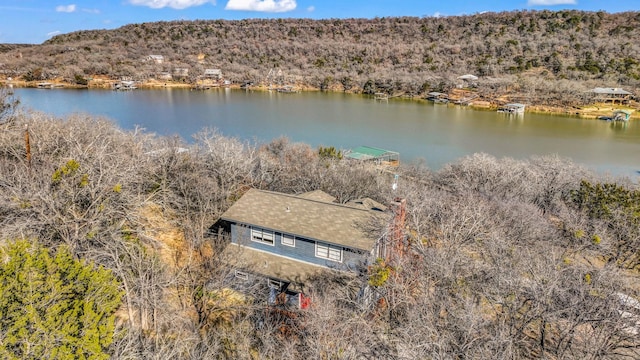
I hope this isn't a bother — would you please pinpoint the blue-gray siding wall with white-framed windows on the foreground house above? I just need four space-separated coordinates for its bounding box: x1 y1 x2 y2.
231 224 369 270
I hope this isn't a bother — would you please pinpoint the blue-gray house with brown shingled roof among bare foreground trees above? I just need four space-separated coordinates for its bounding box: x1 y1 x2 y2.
221 189 400 305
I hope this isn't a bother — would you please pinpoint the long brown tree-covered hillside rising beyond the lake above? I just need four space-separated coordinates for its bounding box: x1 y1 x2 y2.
0 11 640 102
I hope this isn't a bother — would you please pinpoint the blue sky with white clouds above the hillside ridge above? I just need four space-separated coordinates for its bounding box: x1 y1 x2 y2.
0 0 640 44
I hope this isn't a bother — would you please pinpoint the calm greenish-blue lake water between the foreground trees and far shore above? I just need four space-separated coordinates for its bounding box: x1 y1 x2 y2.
15 88 640 179
